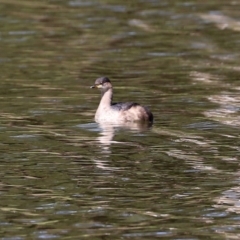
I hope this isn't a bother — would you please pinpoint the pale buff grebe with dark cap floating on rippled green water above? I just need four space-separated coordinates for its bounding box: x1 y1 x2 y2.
91 77 153 123
